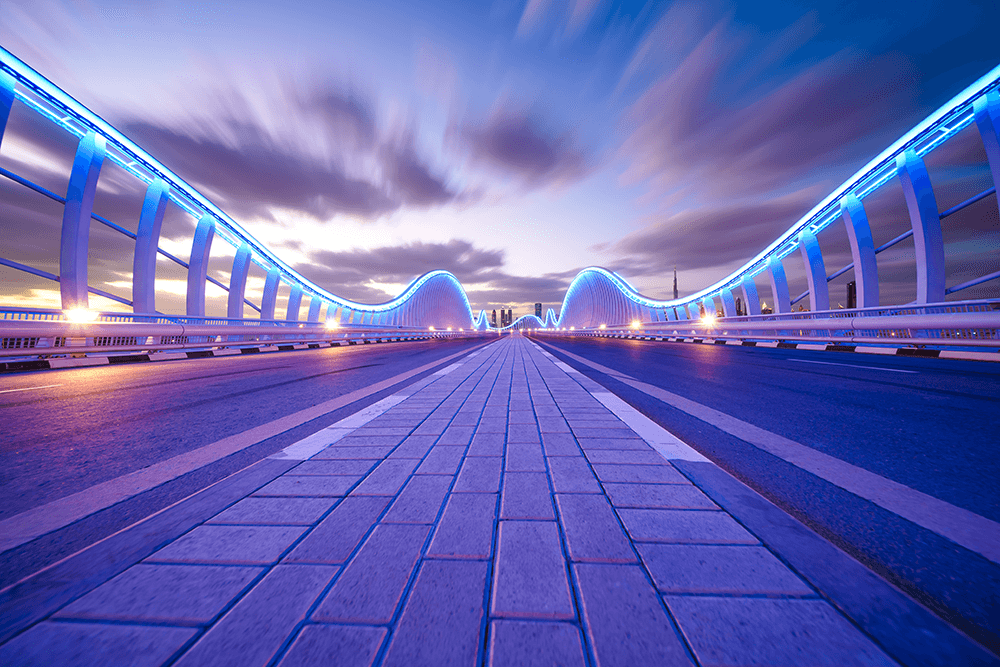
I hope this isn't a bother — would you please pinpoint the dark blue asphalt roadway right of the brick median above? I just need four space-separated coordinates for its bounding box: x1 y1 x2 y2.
536 336 1000 651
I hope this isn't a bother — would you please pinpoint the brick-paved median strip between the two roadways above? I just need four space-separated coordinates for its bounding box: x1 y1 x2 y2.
0 337 897 667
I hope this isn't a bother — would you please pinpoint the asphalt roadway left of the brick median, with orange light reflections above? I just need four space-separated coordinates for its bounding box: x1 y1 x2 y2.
0 339 486 589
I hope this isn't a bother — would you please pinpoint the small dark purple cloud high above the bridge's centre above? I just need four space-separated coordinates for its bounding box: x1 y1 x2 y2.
458 108 590 189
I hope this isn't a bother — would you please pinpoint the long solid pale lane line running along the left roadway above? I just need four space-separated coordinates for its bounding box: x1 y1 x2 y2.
0 342 488 553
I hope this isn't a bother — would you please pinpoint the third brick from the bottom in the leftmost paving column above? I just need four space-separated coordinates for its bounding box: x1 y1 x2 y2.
148 525 306 565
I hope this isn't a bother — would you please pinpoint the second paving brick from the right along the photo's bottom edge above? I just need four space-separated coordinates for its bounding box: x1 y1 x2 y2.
573 563 693 667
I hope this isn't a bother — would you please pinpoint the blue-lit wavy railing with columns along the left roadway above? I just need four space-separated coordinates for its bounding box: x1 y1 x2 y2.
0 48 485 329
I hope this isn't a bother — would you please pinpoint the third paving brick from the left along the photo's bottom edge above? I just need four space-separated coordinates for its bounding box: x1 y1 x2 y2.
278 625 386 667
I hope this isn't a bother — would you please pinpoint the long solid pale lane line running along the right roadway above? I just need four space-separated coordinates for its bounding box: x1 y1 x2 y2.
549 343 1000 563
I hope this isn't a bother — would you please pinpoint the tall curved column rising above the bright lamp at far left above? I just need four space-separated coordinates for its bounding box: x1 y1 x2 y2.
59 132 107 309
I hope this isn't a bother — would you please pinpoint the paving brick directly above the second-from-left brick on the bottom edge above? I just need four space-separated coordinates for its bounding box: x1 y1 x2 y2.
283 496 391 563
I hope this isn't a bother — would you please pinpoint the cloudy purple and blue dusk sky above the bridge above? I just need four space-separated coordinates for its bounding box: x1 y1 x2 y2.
0 0 1000 313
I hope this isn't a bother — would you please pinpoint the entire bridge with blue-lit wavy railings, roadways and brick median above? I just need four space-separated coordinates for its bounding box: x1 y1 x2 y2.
0 44 1000 665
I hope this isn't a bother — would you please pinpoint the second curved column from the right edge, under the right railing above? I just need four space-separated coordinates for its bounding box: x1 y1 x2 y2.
896 149 944 303
